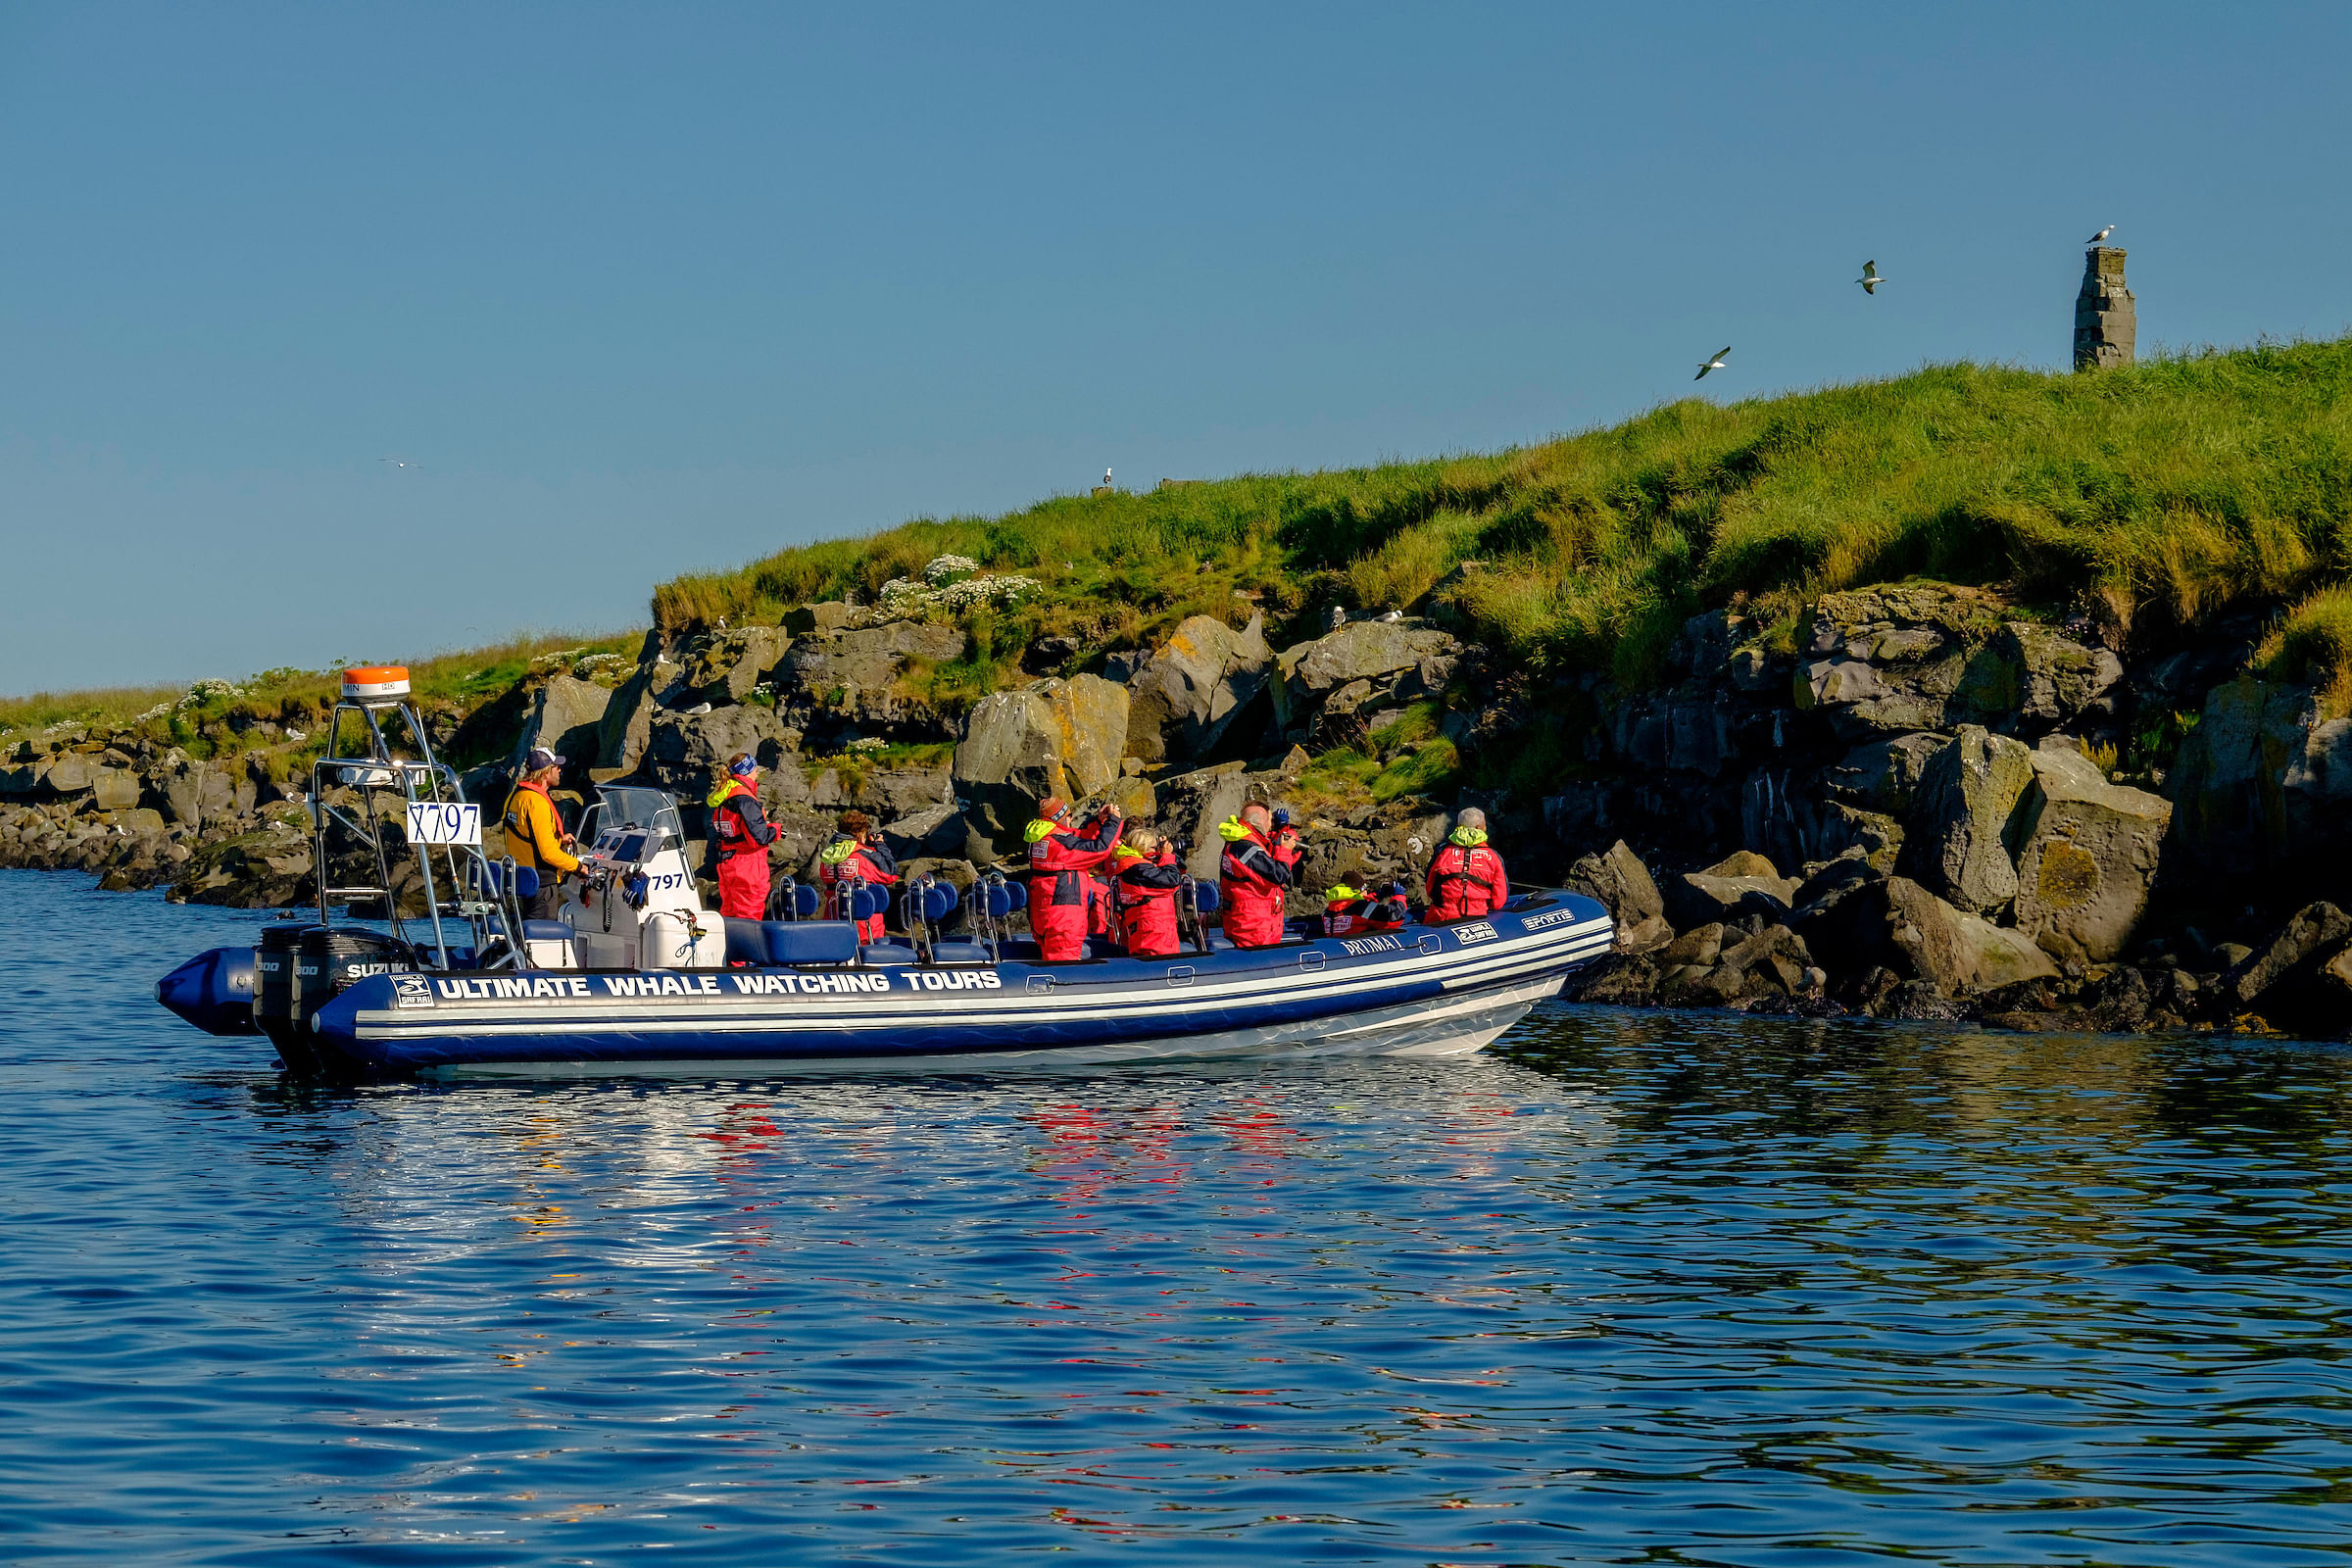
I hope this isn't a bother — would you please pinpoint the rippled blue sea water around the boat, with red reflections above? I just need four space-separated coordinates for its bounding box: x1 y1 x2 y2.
0 872 2352 1568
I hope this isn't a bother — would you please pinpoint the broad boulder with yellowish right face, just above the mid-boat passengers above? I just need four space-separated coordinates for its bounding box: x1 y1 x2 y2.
955 674 1127 856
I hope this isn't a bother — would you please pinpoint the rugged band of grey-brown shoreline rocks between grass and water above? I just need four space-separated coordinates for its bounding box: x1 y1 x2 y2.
0 562 2352 1034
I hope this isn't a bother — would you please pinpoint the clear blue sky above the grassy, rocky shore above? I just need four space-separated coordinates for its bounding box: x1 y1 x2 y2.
0 0 2352 691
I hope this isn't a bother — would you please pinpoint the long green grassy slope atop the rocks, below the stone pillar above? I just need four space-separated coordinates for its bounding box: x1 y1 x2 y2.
654 338 2352 679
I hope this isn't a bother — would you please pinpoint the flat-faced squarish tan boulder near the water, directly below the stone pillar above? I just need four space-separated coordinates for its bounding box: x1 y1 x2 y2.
2016 738 2174 964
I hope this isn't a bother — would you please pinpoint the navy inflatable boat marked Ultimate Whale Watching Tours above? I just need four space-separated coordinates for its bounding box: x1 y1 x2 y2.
155 670 1613 1077
